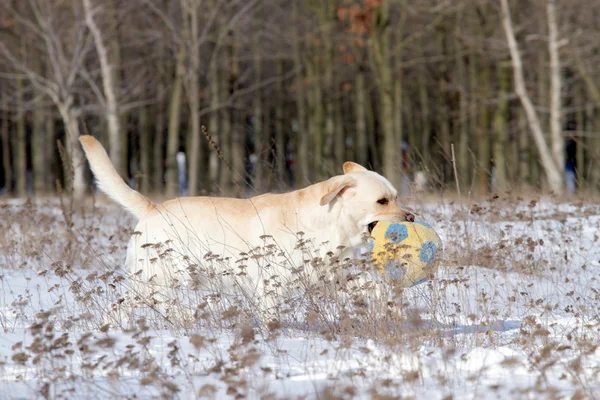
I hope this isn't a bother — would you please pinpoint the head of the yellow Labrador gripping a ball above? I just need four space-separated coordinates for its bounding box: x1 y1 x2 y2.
320 162 415 245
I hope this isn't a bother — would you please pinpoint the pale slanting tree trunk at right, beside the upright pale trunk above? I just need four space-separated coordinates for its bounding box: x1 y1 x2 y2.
500 0 564 194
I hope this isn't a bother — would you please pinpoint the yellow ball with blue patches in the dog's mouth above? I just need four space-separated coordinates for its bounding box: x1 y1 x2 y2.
370 221 442 287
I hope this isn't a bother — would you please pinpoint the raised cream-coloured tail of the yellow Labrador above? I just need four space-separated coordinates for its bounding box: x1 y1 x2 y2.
79 135 154 219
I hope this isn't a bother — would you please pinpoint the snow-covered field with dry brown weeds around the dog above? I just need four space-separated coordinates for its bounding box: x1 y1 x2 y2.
0 195 600 399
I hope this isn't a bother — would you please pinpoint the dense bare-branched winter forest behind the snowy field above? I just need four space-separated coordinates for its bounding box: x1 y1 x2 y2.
0 0 600 198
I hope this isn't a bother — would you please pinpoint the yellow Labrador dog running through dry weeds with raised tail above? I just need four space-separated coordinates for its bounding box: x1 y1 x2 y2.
80 136 414 314
